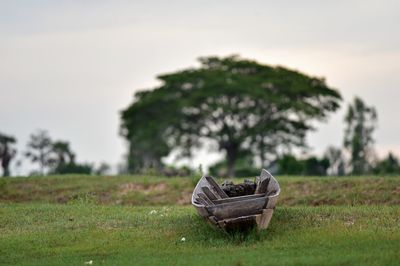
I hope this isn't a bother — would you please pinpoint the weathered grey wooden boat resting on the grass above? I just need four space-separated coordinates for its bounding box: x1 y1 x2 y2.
192 169 280 231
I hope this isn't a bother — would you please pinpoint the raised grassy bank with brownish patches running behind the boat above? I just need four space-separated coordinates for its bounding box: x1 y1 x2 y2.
0 176 400 206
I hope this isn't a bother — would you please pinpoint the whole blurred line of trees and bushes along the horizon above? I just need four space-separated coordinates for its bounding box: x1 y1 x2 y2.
0 55 400 177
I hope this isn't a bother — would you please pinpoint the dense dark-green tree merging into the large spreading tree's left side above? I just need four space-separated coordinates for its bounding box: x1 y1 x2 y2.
121 90 180 173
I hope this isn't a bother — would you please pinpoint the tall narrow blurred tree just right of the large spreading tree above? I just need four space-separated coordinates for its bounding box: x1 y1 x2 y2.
344 97 377 175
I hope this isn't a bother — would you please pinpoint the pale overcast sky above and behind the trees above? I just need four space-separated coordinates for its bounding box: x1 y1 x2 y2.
0 0 400 175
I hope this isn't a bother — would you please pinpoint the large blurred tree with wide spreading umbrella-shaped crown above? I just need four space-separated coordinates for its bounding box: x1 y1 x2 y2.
121 56 341 176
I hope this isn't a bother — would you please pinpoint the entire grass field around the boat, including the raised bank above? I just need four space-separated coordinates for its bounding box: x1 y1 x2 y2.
0 176 400 265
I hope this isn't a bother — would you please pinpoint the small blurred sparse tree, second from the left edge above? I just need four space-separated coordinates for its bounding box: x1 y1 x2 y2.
25 130 54 175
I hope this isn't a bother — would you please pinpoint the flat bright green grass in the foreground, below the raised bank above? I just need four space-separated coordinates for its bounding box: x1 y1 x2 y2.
0 202 400 265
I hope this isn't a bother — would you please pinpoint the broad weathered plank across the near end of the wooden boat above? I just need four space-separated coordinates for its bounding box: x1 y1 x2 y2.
206 197 268 220
